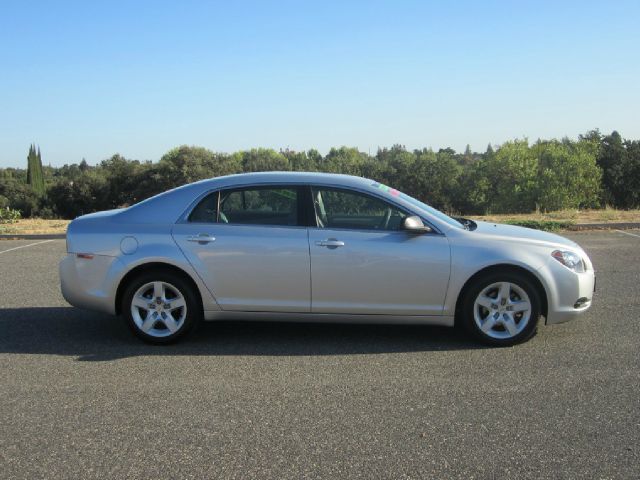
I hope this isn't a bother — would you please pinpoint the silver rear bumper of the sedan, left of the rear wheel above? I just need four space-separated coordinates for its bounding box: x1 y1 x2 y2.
59 253 122 315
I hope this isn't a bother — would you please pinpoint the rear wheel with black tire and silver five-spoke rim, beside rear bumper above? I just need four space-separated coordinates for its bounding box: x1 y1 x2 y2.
121 270 202 345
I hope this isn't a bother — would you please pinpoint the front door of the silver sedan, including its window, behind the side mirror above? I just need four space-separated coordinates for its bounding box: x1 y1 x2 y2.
309 186 450 315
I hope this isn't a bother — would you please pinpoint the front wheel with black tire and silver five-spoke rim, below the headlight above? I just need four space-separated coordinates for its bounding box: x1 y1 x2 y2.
461 272 541 347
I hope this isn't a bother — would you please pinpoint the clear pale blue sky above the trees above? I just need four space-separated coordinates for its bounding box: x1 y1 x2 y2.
0 0 640 167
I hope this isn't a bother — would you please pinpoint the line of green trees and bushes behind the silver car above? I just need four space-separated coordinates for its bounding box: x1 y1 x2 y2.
0 130 640 218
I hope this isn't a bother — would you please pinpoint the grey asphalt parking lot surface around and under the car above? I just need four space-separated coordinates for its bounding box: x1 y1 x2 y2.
0 230 640 479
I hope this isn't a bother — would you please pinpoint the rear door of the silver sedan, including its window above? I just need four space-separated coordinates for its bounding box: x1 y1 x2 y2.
173 185 311 312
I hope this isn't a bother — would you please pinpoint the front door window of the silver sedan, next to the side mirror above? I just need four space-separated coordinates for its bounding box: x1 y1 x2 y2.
313 187 407 230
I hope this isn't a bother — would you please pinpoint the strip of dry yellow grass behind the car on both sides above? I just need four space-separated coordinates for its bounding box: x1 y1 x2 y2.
0 208 640 235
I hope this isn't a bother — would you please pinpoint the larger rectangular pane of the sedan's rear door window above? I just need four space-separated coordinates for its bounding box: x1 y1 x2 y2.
218 187 298 225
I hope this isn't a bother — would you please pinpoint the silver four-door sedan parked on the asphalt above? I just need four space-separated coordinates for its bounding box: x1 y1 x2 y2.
60 172 595 346
